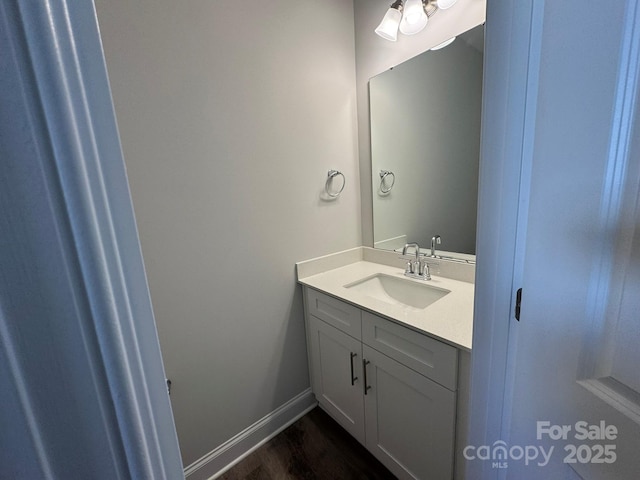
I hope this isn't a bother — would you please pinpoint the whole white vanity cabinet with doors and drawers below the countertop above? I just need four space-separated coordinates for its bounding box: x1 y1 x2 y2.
305 287 458 479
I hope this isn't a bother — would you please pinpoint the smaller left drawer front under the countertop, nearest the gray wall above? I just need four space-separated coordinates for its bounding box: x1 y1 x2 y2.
307 288 362 339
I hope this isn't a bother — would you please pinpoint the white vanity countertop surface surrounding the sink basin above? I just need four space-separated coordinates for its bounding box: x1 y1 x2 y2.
298 260 474 351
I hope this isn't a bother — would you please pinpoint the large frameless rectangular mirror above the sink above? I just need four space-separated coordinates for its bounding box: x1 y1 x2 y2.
369 25 484 259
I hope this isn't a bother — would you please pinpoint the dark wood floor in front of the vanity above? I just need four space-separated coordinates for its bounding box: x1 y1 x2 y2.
219 407 396 480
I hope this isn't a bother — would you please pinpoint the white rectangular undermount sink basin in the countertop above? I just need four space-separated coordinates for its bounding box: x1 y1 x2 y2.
345 273 451 309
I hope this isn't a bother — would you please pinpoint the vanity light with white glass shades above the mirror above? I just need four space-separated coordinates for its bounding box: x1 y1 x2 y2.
375 0 457 42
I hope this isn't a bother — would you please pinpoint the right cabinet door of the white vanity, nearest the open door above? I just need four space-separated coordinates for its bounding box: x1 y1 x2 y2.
363 345 456 480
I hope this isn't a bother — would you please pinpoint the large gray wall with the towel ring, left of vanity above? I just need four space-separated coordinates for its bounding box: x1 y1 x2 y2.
96 0 362 465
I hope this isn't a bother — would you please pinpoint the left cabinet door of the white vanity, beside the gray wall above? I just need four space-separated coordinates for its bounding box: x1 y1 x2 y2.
309 315 364 445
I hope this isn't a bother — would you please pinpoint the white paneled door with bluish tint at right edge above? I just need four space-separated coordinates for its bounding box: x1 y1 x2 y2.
498 0 640 480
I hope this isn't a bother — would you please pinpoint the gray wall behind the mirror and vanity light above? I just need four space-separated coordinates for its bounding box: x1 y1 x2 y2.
353 0 486 246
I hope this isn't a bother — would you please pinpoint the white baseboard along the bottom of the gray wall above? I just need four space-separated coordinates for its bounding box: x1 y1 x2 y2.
184 388 318 480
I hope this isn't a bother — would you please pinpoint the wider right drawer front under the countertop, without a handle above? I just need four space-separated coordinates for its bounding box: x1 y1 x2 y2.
362 312 458 390
